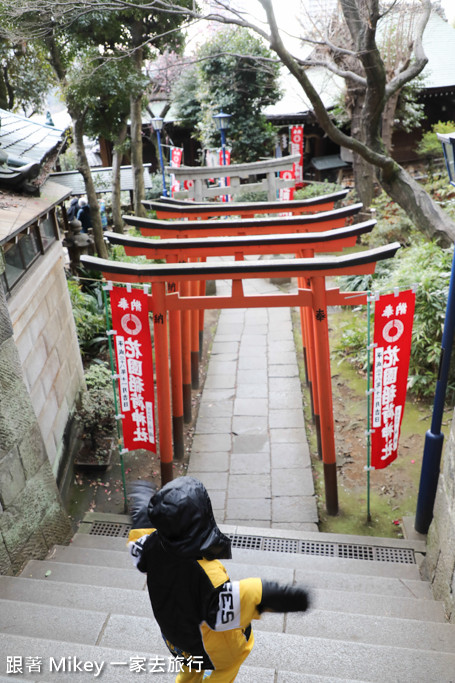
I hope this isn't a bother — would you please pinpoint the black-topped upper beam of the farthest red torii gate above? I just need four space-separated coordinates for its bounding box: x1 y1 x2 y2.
142 189 349 220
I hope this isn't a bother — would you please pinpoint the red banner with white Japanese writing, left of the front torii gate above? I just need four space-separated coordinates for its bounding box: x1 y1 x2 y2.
110 287 156 453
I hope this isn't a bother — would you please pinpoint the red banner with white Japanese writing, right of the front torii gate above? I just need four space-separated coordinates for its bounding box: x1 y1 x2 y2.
371 290 415 470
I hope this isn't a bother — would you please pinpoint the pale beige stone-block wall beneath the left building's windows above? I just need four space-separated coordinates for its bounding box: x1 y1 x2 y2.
8 242 84 476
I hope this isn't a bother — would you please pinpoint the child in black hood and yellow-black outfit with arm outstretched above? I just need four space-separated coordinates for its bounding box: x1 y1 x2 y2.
128 477 308 683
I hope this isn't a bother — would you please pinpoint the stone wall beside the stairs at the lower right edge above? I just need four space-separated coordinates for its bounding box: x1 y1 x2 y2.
426 413 455 623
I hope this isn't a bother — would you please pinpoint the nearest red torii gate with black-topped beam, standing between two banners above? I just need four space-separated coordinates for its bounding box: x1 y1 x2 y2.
81 242 400 515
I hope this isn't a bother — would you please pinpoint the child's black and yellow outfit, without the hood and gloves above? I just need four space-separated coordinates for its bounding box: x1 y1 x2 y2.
128 530 262 669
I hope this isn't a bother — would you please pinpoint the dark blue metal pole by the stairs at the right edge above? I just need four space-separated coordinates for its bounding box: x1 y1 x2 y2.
414 246 455 534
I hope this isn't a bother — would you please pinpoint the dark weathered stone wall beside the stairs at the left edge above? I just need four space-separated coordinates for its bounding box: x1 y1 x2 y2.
0 270 71 574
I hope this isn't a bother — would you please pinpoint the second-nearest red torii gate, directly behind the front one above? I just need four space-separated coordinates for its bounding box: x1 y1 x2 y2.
105 220 376 458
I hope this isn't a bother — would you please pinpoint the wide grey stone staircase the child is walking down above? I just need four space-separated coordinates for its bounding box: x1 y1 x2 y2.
0 513 455 683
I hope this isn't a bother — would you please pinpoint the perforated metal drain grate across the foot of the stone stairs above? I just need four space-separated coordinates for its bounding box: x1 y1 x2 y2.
90 521 416 564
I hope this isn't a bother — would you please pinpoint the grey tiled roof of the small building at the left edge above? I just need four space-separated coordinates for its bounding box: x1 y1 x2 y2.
0 109 64 164
